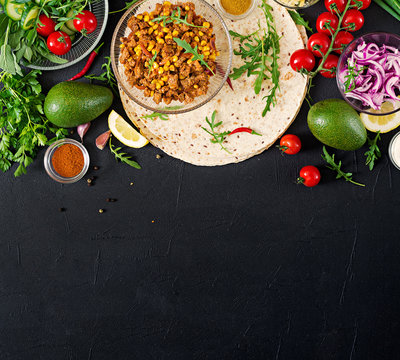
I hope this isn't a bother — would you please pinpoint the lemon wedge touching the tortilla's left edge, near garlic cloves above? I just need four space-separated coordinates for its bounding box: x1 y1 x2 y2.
108 110 149 149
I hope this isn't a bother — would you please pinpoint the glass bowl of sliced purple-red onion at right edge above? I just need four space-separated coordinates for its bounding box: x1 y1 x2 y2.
336 32 400 115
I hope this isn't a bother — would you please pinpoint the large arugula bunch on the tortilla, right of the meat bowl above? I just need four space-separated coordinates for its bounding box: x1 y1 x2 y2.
230 0 280 116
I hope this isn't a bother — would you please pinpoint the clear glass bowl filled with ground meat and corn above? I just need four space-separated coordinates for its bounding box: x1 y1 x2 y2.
111 0 232 114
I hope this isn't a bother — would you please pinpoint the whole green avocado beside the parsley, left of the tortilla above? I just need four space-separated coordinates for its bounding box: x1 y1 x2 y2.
44 81 114 128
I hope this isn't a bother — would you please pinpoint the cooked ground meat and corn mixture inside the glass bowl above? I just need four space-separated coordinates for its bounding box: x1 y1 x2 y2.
120 1 219 105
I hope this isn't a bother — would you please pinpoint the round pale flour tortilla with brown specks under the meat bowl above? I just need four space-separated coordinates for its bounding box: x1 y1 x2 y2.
120 0 307 166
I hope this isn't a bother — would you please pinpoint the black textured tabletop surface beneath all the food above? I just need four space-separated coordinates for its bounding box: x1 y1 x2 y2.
0 0 400 360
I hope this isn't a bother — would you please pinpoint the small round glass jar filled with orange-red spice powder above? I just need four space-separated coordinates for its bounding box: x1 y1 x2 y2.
44 139 90 184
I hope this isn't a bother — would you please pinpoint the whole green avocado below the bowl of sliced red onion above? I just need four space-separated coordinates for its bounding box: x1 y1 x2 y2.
307 99 367 151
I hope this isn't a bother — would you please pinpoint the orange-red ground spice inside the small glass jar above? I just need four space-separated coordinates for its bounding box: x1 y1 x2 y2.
51 144 85 178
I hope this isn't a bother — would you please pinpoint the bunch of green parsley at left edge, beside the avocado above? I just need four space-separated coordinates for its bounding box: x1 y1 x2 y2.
0 70 68 176
